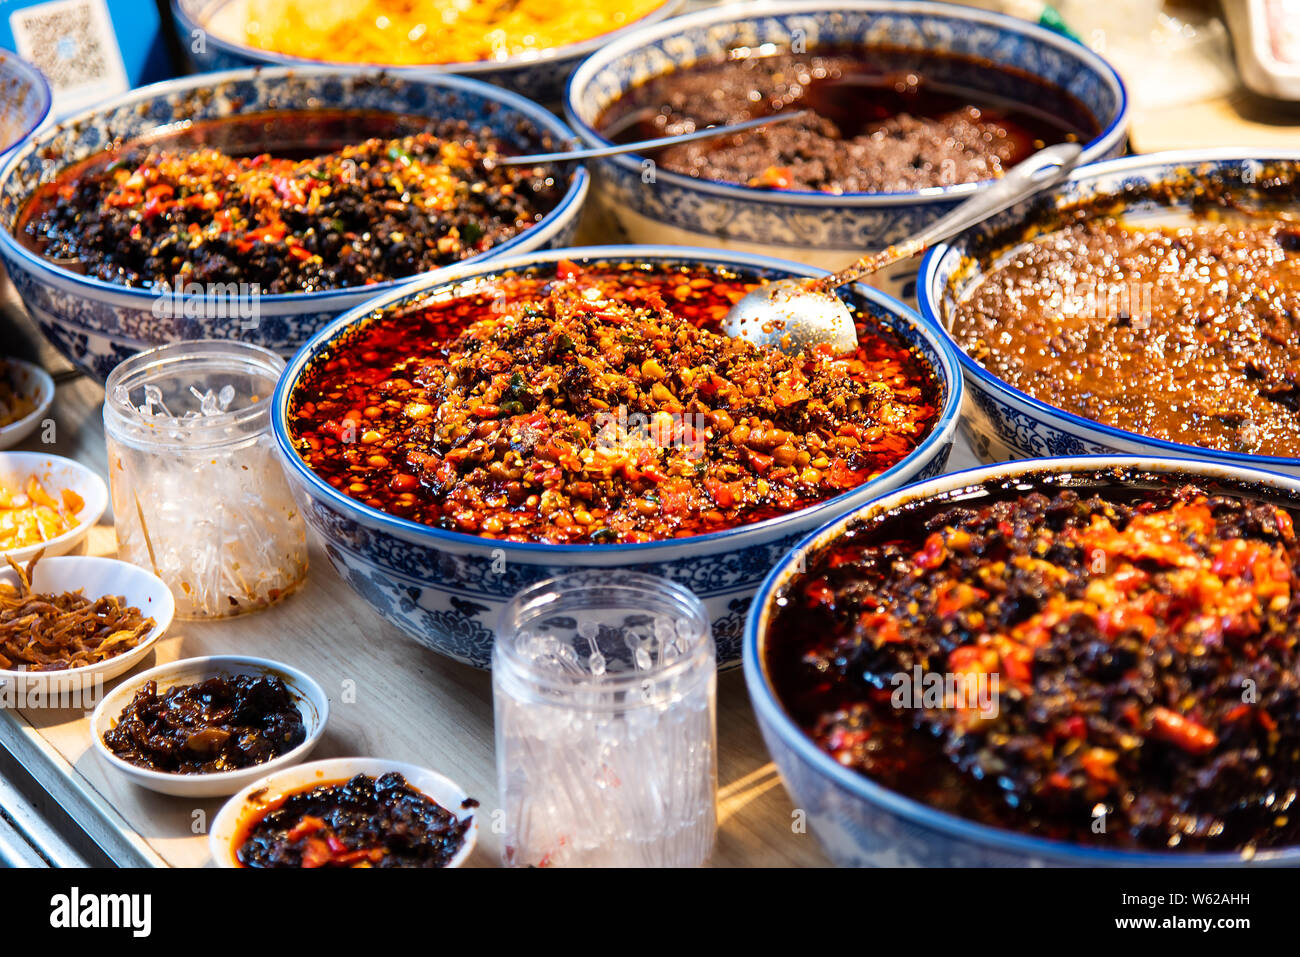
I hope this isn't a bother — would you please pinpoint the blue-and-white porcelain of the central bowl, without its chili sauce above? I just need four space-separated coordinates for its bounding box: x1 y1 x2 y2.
272 246 962 668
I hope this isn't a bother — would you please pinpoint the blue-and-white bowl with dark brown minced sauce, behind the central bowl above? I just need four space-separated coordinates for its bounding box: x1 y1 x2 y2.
564 0 1127 298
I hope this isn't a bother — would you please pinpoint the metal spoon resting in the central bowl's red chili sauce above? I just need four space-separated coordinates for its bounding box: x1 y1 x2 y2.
722 143 1083 355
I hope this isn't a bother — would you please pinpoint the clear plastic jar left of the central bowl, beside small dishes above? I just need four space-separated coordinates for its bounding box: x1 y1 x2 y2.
104 339 307 618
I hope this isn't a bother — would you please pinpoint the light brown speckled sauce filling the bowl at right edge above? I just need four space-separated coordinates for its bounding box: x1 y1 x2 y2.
952 215 1300 456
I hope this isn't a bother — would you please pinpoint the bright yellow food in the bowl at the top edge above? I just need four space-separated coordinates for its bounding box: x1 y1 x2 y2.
230 0 666 66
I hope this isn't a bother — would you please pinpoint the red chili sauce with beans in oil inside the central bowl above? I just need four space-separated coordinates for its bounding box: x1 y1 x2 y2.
289 263 940 544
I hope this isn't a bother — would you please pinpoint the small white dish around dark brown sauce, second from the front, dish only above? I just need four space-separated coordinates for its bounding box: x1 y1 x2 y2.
89 650 329 797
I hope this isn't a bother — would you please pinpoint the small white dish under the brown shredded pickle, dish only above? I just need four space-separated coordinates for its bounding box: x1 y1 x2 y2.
0 555 176 706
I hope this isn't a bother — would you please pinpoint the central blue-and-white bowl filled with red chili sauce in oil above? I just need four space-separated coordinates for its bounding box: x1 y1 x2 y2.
272 246 961 667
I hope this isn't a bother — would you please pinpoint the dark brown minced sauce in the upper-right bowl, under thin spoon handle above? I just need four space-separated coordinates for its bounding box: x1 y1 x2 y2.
597 47 1100 192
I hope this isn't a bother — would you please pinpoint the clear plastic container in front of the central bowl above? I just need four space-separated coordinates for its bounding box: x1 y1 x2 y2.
493 571 718 867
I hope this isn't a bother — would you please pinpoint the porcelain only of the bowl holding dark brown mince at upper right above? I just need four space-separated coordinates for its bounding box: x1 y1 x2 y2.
564 0 1128 295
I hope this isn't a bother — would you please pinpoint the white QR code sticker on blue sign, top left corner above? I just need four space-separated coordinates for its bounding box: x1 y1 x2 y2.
9 0 129 113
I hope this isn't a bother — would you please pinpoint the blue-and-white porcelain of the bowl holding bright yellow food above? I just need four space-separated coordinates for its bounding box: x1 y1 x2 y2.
172 0 685 103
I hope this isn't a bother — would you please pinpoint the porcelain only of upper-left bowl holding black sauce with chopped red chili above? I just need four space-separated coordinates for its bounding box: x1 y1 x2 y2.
0 68 589 380
